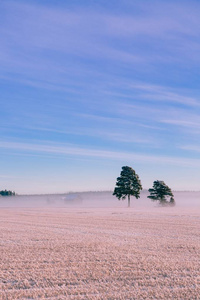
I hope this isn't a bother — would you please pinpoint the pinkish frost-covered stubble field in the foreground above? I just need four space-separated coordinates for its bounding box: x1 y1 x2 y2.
0 193 200 300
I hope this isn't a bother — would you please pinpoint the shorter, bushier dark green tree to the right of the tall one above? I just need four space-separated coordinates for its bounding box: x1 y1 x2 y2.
148 180 175 205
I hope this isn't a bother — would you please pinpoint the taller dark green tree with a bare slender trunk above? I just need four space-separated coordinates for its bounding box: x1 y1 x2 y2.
113 166 142 207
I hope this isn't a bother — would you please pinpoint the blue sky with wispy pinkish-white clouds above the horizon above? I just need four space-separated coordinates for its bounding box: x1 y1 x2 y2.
0 0 200 194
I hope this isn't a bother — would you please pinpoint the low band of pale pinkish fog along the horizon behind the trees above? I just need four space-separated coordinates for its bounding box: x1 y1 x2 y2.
0 190 200 209
